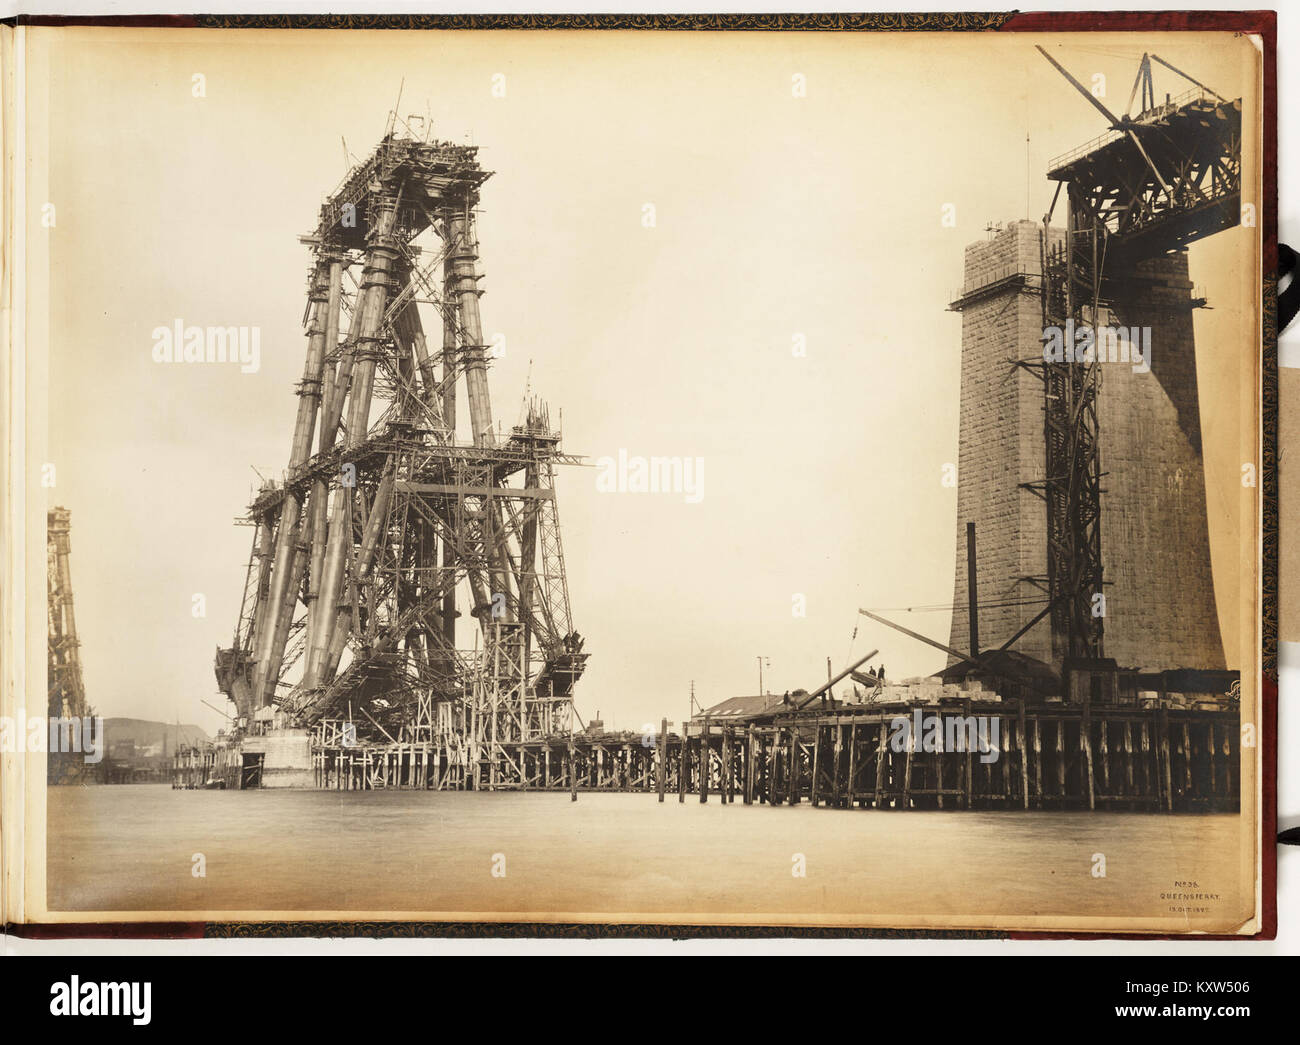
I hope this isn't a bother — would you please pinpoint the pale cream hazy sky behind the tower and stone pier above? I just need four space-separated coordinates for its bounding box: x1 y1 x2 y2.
33 29 1257 730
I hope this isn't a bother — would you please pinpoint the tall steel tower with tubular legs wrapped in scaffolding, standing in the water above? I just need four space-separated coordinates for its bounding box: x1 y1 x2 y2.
216 117 588 786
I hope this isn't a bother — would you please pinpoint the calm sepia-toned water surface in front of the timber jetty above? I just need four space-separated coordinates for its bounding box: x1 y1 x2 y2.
47 785 1240 922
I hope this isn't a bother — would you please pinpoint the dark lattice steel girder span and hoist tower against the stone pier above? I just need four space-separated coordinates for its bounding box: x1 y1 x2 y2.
1027 47 1242 659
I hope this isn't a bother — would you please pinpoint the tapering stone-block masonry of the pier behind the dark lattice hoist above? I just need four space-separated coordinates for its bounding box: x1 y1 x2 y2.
949 221 1223 671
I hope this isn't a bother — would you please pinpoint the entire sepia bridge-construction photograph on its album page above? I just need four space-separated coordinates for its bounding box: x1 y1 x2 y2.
3 8 1278 938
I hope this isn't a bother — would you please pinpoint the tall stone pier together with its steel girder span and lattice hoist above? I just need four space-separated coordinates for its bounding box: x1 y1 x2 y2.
952 55 1242 669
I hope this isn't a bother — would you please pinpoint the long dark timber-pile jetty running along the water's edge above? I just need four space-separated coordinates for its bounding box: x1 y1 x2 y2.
276 697 1242 812
